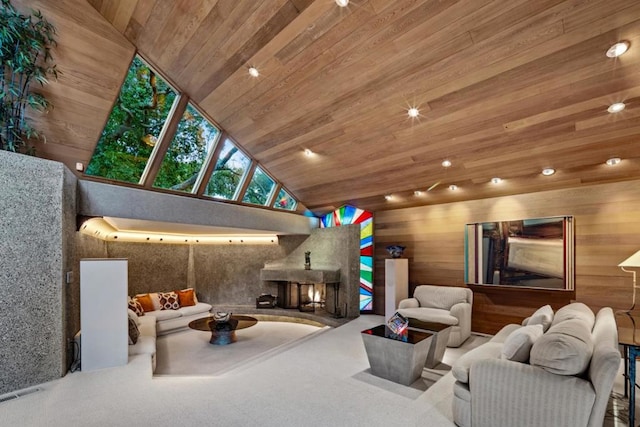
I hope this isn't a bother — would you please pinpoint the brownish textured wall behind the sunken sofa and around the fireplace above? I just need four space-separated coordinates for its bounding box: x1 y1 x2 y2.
78 231 360 317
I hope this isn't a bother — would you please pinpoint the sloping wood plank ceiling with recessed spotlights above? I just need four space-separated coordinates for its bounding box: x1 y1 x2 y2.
28 0 640 213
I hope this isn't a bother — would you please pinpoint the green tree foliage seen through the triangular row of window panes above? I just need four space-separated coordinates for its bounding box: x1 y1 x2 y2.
86 56 295 209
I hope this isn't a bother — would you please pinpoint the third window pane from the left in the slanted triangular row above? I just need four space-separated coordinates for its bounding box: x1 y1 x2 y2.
204 138 251 200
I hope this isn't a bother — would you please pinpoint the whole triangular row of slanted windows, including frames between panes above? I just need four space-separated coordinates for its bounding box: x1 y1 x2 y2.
83 55 298 211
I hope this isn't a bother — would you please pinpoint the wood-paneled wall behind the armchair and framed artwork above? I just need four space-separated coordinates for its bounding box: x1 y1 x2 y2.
374 181 640 333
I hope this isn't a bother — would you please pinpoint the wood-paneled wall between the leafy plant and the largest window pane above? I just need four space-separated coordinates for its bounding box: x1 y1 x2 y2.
12 0 135 170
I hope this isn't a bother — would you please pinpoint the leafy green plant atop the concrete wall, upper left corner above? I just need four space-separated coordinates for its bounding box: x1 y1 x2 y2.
0 0 58 153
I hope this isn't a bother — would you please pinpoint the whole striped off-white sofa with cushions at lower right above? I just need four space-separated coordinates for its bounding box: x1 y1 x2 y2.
452 303 621 427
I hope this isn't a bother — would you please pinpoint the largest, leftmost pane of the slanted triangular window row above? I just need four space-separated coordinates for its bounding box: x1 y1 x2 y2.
85 56 178 183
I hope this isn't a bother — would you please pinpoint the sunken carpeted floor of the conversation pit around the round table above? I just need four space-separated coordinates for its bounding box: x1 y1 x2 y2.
154 322 330 376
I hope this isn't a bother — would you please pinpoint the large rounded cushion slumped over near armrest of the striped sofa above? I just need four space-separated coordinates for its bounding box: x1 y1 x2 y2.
529 318 593 375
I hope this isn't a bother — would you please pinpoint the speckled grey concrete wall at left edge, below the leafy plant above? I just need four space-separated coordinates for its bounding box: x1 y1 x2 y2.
0 151 75 394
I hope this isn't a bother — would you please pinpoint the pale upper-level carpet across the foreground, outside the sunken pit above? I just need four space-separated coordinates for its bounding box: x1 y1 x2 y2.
0 315 626 427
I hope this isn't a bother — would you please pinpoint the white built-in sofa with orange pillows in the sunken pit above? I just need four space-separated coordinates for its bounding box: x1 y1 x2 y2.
128 294 211 371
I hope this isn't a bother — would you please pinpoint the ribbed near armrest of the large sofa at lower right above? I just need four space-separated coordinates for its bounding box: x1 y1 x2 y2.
469 359 595 427
